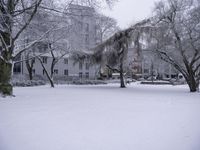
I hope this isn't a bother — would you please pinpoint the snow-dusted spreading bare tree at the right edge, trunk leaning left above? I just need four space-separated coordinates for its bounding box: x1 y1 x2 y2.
150 0 200 92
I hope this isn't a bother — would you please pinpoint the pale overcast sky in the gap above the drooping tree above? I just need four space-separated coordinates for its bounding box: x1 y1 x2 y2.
103 0 158 28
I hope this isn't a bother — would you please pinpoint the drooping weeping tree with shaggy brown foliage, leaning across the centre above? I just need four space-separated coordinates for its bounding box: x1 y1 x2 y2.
73 19 152 88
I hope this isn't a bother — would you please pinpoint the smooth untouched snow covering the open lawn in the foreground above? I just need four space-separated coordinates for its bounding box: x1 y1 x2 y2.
0 83 200 150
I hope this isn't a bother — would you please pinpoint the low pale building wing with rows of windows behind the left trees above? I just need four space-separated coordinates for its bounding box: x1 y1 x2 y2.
20 48 96 80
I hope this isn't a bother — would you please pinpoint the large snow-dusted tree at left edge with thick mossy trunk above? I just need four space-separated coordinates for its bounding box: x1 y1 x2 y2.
0 0 115 95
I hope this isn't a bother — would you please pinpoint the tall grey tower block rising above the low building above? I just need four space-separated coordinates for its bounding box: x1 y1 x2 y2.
68 4 97 50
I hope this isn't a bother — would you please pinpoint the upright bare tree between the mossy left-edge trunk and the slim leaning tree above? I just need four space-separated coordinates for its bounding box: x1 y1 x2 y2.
23 3 68 80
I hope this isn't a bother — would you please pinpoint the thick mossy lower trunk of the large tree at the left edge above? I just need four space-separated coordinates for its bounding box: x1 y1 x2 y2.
0 59 13 95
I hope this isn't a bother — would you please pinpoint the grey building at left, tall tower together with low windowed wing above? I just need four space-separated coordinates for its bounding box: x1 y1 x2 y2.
14 4 98 79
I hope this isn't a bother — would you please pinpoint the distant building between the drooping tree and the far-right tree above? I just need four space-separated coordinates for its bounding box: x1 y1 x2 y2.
127 48 178 79
